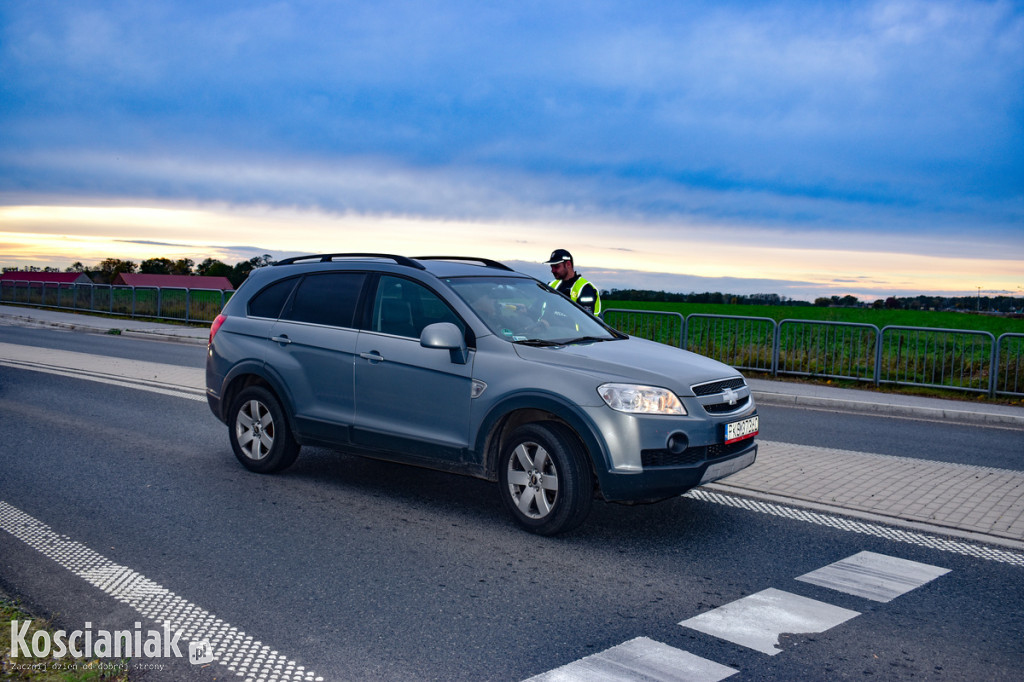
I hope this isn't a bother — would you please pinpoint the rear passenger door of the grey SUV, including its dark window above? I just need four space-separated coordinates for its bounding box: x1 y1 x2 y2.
266 272 367 442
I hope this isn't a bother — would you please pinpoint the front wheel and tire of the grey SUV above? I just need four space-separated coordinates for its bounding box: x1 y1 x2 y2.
498 422 594 536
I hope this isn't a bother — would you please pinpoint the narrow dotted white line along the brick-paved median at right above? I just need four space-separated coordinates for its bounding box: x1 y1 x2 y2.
683 488 1024 566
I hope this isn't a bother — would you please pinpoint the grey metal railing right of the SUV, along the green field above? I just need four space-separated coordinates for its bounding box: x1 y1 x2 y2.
601 308 1024 397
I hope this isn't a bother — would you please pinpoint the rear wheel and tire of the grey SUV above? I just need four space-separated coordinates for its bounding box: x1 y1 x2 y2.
227 386 299 473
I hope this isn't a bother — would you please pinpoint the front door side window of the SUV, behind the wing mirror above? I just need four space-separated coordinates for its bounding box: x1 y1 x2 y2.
371 274 466 339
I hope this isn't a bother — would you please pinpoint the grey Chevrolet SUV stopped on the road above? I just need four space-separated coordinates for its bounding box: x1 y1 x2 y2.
206 254 758 535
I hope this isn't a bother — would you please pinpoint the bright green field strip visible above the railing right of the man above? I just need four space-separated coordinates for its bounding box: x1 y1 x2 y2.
601 299 1024 337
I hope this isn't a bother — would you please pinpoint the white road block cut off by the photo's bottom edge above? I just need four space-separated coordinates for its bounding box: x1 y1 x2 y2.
527 637 738 682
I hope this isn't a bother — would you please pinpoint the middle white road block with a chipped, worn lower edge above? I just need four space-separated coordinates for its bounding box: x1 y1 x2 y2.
679 588 860 655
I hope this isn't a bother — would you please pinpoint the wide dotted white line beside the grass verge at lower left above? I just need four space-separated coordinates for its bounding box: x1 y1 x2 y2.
0 501 324 682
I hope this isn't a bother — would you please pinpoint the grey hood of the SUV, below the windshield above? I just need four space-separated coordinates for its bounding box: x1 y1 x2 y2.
515 337 739 395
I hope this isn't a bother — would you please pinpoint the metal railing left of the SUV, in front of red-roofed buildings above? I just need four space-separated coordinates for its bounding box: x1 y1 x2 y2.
0 281 233 322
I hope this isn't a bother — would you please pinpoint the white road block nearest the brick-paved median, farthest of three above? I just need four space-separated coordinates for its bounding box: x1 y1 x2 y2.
797 552 949 603
